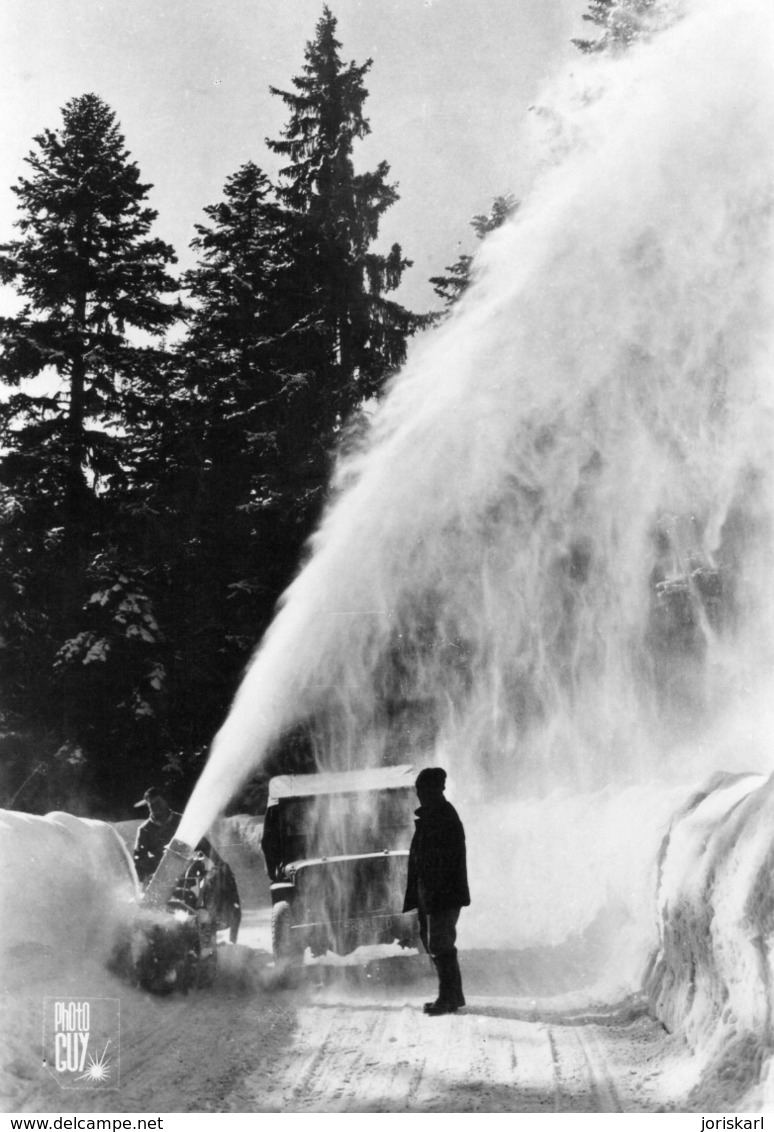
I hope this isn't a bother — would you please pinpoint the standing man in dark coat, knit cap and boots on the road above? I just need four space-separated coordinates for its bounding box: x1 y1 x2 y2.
403 766 471 1015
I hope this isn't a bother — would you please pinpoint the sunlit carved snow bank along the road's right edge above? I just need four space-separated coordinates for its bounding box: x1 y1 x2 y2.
646 774 774 1103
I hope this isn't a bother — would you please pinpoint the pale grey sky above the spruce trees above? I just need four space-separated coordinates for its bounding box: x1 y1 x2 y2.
0 0 587 309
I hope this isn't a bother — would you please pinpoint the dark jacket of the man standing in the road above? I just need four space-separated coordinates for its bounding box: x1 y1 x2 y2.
403 795 471 914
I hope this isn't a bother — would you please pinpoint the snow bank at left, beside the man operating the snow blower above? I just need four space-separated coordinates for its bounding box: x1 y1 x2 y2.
0 811 138 963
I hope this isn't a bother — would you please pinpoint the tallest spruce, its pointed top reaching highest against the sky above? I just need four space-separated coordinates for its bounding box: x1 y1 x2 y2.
267 7 421 487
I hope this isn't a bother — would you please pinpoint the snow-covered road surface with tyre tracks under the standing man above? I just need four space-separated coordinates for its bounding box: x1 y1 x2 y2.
0 937 706 1113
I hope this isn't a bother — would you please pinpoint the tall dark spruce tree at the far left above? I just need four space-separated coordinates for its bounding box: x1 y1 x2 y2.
0 94 179 787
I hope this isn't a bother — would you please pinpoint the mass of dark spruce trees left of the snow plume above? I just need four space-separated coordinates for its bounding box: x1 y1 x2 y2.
0 0 665 816
